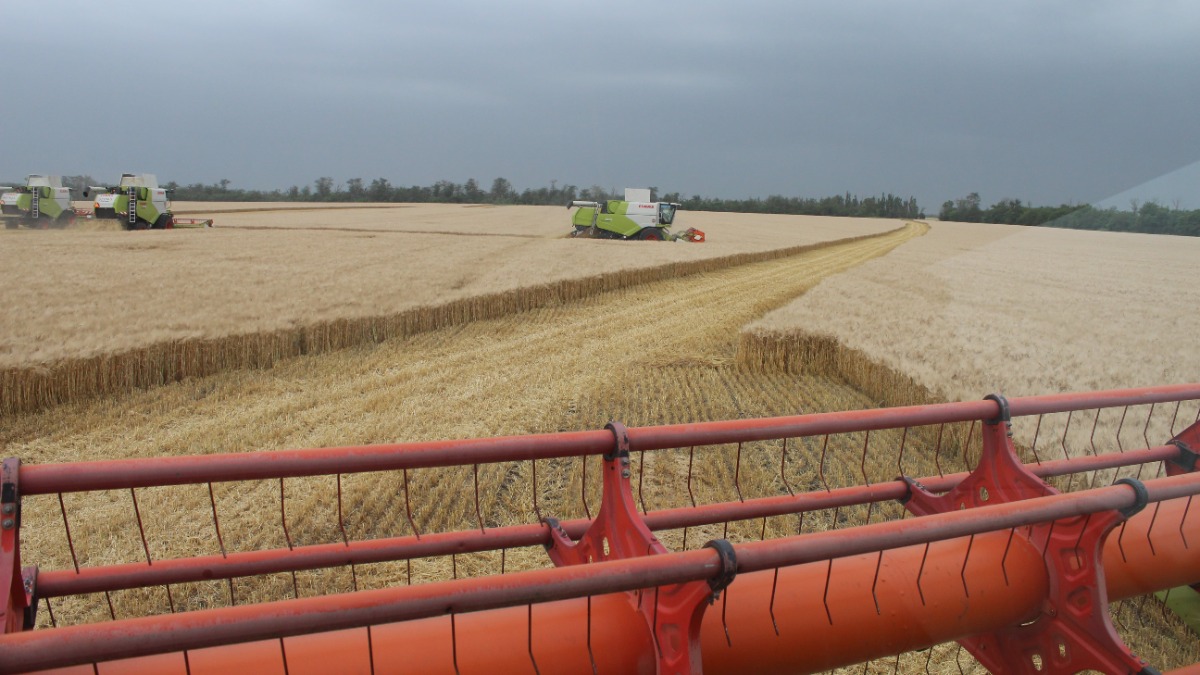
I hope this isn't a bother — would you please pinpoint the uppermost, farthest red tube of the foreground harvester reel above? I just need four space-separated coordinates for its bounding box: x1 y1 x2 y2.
20 384 1200 495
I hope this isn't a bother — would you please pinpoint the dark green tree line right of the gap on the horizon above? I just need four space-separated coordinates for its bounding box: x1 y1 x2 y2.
937 192 1200 237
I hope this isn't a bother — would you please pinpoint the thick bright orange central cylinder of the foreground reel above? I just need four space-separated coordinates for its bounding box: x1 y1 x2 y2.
28 500 1200 675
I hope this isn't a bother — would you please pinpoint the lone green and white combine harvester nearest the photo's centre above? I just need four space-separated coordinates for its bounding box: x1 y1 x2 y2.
566 187 704 243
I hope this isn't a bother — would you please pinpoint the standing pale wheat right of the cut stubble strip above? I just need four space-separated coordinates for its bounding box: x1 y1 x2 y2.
746 222 1200 400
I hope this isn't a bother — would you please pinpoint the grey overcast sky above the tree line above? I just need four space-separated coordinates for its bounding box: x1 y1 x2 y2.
0 0 1200 213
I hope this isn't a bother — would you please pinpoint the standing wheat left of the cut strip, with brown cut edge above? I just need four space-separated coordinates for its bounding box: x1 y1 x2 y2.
0 207 899 414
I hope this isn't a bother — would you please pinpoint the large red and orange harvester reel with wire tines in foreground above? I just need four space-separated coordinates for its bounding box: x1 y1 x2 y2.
0 384 1200 675
